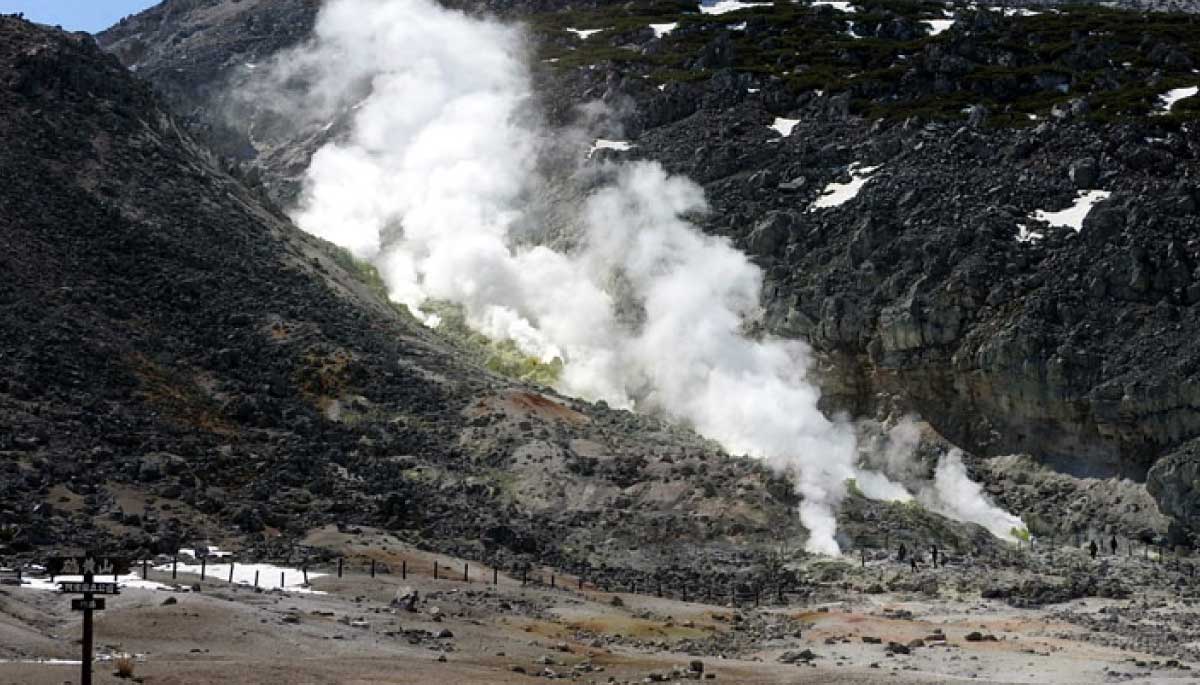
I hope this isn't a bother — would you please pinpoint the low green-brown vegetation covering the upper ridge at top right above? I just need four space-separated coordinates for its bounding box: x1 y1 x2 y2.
527 0 1200 126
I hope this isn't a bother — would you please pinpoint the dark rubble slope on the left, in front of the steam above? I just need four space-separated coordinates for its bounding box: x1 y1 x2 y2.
0 12 868 577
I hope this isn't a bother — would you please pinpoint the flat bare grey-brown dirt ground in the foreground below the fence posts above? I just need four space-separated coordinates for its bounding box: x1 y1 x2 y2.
0 529 1198 685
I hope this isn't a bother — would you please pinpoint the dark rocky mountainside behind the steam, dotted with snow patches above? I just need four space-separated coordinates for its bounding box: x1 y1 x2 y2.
100 0 1200 530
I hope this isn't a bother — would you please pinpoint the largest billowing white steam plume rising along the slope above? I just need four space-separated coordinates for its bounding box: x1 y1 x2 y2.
253 0 1022 554
